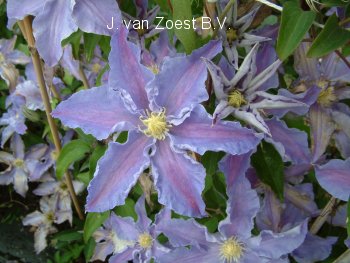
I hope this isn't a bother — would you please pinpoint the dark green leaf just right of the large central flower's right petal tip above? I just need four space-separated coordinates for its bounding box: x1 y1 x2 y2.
251 141 284 201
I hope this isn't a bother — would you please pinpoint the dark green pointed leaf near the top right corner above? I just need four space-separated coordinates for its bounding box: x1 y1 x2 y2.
307 14 350 57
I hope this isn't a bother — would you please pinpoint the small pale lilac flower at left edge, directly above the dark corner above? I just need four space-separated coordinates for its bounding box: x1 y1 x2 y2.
0 134 47 196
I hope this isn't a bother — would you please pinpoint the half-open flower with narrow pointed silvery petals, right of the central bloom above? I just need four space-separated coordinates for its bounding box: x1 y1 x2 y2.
206 45 306 136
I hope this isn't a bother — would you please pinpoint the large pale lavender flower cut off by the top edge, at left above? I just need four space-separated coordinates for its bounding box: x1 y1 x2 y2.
7 0 121 67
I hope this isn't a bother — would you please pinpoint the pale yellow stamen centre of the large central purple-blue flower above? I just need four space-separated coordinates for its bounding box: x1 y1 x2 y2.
140 109 171 140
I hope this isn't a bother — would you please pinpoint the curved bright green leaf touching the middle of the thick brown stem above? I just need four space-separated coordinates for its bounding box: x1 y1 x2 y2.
56 140 90 180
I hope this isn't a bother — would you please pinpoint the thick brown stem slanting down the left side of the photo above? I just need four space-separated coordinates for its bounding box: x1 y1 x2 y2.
18 16 84 220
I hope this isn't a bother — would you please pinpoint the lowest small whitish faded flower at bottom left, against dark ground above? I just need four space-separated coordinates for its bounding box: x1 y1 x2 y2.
22 197 70 254
